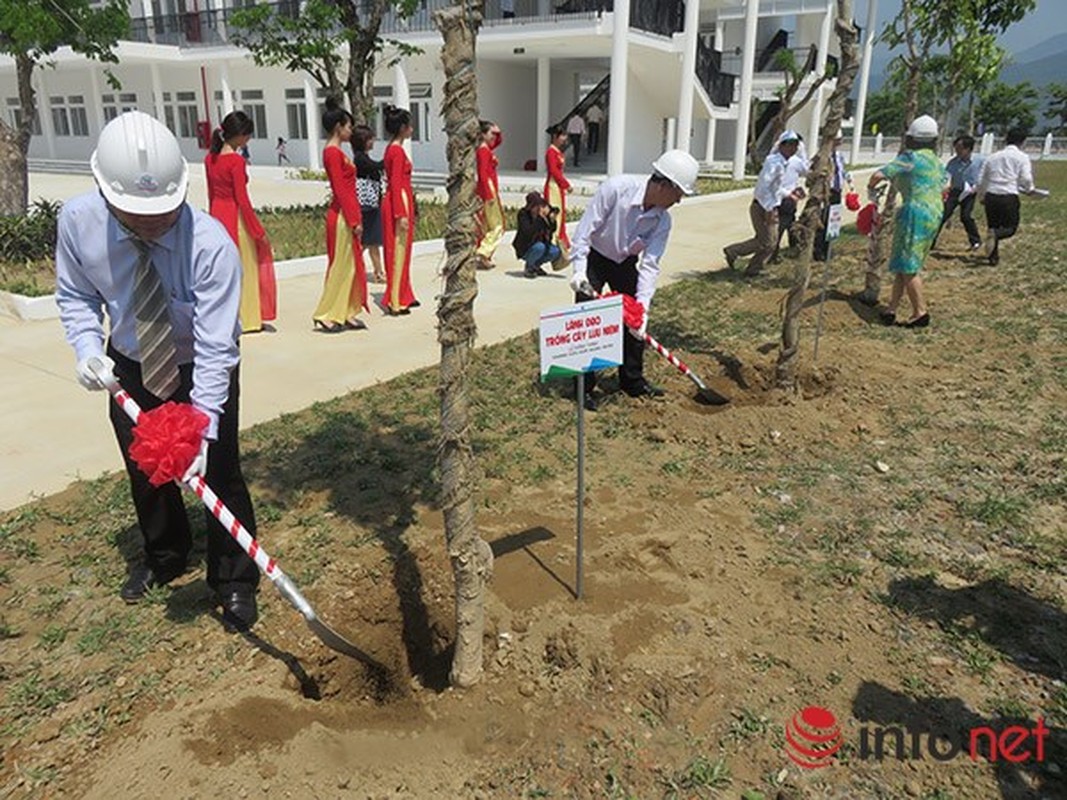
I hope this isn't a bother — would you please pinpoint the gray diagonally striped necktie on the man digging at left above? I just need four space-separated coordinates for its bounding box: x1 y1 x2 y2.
133 238 179 400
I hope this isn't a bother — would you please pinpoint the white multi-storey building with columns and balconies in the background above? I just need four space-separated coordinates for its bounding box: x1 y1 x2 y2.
0 0 877 177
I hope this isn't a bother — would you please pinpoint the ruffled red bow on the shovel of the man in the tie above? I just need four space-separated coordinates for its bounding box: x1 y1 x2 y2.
130 401 209 486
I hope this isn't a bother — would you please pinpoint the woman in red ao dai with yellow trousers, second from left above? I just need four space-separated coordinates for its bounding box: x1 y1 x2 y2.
312 97 369 333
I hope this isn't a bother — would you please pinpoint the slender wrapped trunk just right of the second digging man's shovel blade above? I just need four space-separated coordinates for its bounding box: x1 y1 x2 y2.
775 0 859 389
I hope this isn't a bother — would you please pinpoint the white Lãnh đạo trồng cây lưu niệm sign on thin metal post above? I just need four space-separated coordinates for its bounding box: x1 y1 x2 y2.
540 294 623 599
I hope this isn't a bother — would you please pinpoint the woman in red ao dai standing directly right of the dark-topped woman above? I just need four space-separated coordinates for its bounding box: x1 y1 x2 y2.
382 106 419 317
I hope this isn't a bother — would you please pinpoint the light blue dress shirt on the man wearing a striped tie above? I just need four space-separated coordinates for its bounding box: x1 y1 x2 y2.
55 191 241 438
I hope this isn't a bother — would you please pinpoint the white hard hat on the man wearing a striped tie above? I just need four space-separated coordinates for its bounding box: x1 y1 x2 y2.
89 111 189 214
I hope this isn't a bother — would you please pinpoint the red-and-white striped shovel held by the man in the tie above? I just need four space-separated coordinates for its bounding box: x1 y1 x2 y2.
89 358 381 667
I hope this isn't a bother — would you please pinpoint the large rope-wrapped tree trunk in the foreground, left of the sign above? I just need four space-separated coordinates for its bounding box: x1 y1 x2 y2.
434 0 493 687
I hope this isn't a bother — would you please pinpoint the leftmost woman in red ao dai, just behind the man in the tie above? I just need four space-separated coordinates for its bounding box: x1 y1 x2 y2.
204 111 277 333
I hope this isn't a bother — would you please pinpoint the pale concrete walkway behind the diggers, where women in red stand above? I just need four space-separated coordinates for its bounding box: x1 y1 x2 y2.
0 167 768 510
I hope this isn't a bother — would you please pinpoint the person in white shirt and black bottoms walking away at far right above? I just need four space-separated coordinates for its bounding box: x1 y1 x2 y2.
978 128 1034 265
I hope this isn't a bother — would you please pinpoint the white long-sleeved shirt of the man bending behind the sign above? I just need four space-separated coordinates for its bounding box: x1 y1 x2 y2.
571 175 671 310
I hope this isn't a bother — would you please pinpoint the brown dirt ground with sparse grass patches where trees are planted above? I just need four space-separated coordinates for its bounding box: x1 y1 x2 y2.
0 164 1067 800
